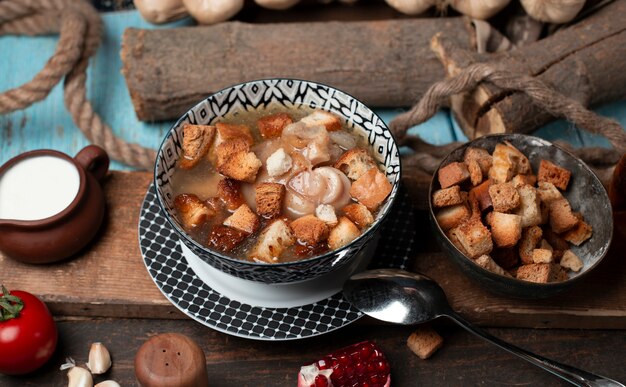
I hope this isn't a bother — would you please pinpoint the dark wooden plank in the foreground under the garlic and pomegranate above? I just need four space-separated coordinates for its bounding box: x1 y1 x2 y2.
0 319 626 387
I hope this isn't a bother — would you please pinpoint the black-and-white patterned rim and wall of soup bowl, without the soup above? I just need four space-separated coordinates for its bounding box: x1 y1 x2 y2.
154 79 400 284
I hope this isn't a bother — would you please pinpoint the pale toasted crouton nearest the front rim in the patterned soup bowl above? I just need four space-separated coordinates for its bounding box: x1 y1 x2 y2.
249 219 295 263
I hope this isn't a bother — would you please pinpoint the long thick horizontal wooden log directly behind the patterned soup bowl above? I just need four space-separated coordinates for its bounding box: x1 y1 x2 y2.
121 18 470 120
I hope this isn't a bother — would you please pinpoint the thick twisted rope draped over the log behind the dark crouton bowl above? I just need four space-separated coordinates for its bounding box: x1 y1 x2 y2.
389 63 626 173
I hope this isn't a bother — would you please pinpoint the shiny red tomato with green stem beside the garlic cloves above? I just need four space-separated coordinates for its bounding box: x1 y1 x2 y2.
0 290 58 375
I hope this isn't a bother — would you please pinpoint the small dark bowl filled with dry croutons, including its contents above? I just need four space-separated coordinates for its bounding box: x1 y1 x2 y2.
429 134 613 298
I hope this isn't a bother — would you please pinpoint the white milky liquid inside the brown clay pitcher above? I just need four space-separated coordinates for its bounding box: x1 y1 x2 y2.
0 156 80 220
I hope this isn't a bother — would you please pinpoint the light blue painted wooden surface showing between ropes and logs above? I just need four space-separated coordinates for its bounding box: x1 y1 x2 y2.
0 11 626 169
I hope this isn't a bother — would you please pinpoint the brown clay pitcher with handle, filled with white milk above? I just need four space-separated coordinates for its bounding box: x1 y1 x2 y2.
0 145 109 263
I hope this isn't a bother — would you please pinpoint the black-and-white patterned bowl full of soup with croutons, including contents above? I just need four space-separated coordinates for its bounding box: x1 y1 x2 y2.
154 79 400 284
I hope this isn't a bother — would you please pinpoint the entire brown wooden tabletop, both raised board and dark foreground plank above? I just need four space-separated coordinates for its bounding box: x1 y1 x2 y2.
0 171 626 386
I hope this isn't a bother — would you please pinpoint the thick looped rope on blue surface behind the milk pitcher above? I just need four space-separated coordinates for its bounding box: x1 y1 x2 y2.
0 0 156 169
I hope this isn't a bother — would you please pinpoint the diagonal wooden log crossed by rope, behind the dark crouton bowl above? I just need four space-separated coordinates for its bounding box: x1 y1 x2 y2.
432 0 626 139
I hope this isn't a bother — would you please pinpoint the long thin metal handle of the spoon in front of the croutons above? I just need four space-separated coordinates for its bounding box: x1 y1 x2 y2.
447 310 625 387
